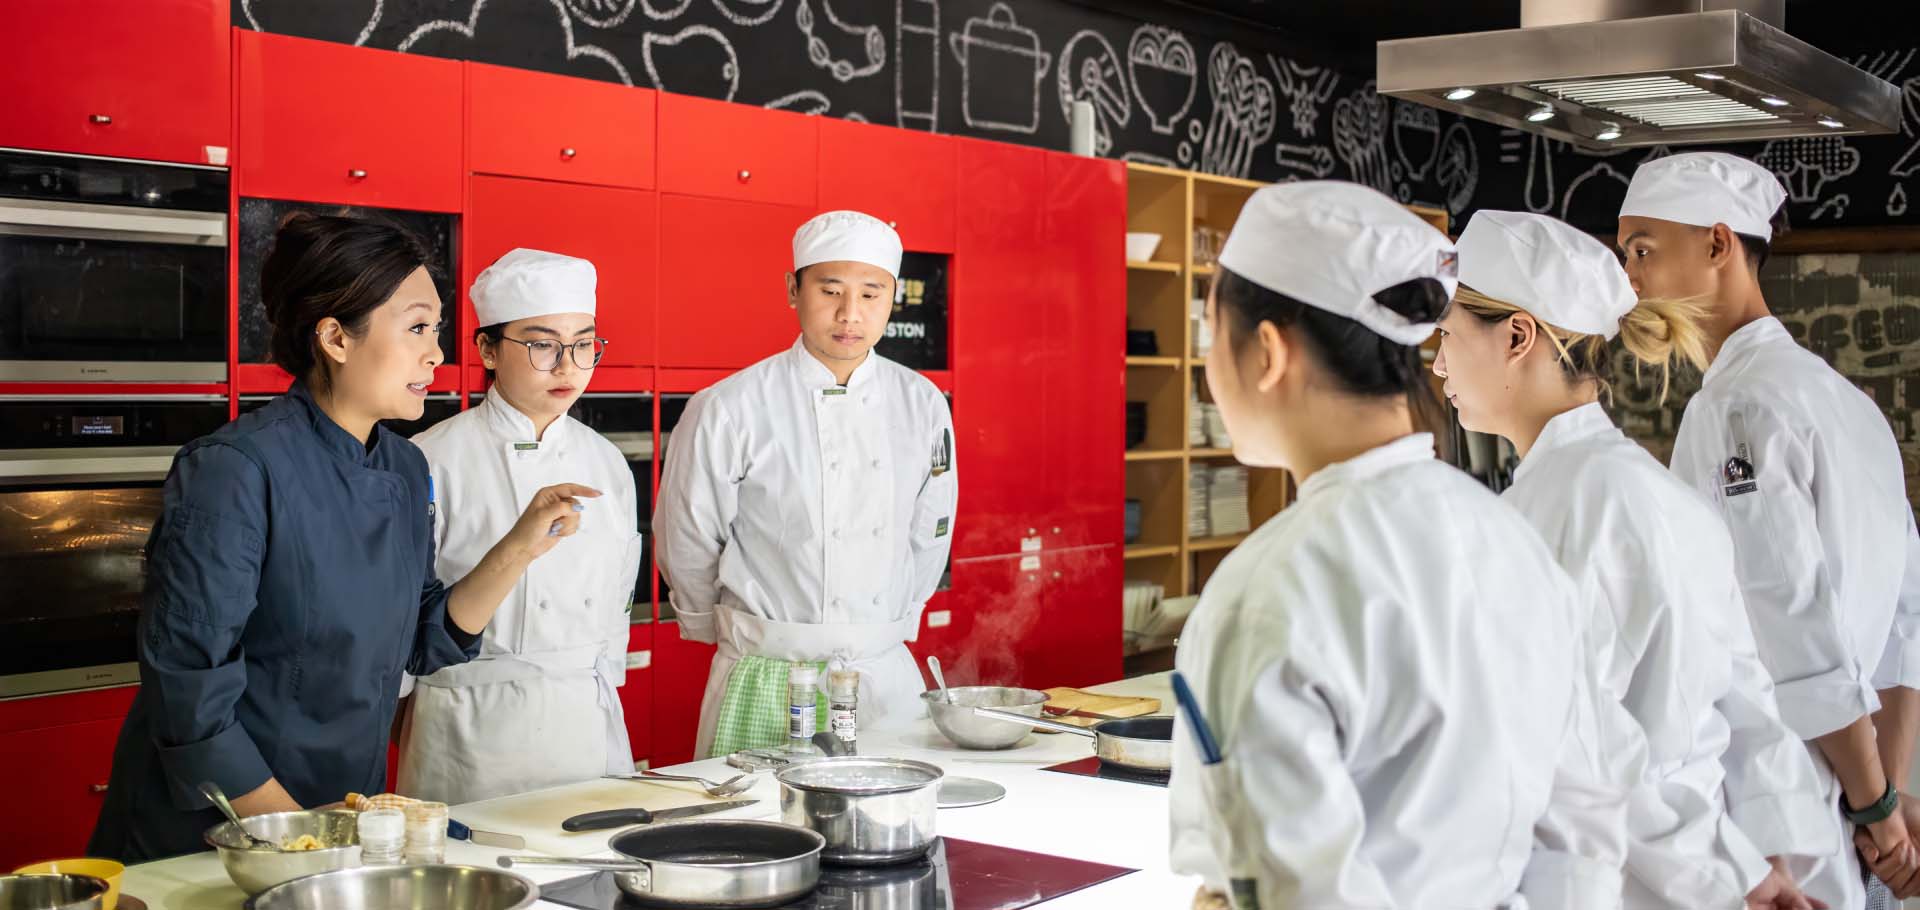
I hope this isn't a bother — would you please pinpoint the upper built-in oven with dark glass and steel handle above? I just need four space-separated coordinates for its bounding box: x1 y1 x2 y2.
0 150 228 382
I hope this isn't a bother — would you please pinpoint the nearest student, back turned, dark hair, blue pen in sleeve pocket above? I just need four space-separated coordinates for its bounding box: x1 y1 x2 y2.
1169 180 1644 910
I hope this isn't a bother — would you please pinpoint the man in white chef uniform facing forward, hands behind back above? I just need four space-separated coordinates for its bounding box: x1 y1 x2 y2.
653 211 956 756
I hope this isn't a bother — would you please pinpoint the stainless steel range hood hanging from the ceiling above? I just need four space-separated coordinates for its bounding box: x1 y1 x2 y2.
1377 0 1901 148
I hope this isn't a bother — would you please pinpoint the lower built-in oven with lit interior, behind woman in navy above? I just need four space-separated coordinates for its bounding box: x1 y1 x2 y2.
0 395 227 699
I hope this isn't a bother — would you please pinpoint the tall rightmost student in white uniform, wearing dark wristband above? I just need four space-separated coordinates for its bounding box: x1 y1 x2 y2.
1619 152 1920 910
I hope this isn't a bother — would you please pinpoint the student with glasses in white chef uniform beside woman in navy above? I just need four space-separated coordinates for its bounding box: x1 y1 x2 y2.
396 250 641 802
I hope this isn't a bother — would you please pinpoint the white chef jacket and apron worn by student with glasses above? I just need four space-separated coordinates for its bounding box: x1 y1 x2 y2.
396 395 641 804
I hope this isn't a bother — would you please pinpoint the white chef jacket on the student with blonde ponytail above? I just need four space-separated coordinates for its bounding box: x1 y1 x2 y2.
1501 403 1845 910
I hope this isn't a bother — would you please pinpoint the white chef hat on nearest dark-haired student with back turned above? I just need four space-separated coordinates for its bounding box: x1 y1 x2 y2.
1219 180 1457 344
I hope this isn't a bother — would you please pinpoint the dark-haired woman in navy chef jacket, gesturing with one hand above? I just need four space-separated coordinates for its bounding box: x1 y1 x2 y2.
88 215 599 862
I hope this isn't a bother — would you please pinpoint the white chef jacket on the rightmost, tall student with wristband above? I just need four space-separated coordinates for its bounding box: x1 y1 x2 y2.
1672 317 1920 908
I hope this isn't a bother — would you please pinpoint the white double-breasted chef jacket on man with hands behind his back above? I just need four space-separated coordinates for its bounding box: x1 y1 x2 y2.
653 340 958 754
